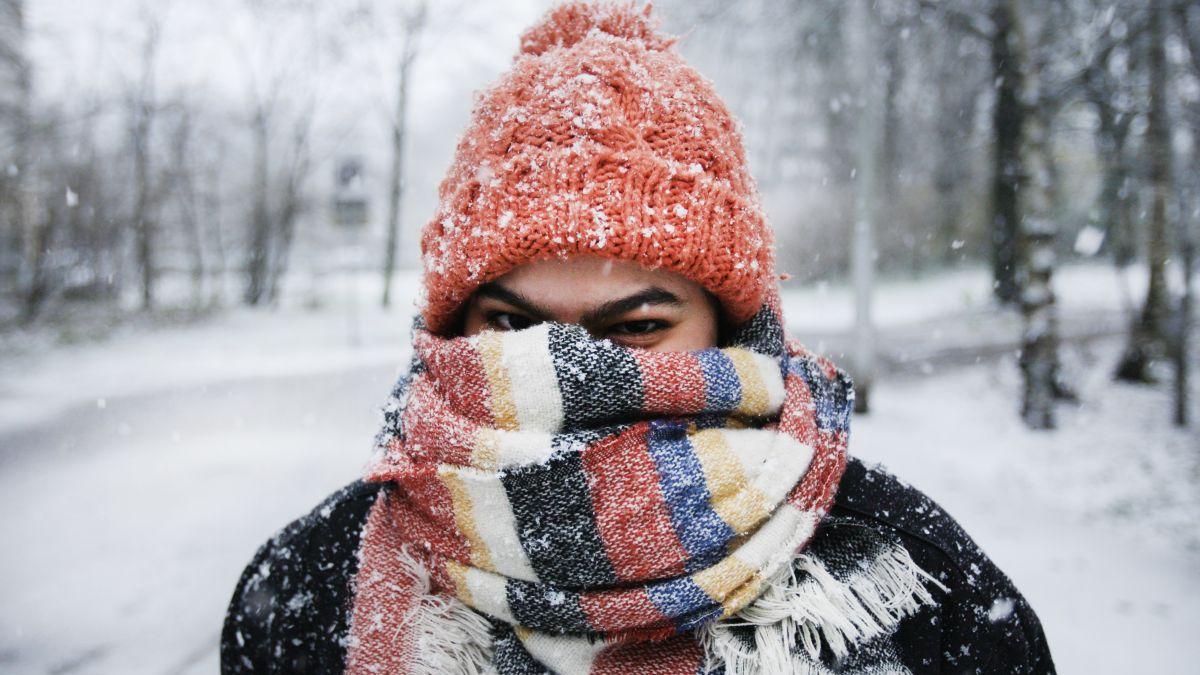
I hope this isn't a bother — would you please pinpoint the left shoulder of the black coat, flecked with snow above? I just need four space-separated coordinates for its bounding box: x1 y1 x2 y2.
221 480 383 674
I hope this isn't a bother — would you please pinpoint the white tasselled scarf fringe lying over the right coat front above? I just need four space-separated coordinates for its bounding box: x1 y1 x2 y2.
701 544 947 675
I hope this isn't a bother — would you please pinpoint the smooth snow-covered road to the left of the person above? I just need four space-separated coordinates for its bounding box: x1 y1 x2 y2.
0 366 392 674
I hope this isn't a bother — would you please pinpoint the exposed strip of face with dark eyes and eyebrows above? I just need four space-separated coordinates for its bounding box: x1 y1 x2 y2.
462 257 720 351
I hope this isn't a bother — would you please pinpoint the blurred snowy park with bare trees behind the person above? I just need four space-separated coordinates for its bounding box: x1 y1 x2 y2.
0 0 1200 674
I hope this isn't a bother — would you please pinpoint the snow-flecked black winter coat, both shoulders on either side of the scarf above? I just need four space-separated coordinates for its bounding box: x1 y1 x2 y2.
221 460 1055 674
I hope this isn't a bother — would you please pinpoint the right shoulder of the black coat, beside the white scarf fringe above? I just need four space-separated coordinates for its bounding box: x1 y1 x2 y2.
833 459 1055 674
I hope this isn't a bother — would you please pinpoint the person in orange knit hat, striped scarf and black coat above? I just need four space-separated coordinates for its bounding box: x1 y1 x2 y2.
221 2 1054 674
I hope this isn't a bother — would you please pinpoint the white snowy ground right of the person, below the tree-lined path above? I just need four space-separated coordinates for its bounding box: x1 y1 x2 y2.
851 340 1200 675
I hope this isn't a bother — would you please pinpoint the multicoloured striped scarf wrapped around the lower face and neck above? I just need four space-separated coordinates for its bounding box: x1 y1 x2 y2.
348 307 923 673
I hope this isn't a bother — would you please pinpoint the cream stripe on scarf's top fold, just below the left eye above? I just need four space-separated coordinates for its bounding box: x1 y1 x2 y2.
503 323 563 434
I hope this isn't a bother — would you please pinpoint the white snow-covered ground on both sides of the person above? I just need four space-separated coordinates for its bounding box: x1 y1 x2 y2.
0 267 1200 673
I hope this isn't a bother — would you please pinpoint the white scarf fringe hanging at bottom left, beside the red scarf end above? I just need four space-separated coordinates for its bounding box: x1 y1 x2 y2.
396 546 496 675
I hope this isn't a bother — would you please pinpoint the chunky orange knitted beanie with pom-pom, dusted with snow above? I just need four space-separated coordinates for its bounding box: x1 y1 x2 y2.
421 2 775 333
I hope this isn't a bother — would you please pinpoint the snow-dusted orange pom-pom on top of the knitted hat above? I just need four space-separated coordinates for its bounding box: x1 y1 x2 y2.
517 2 677 58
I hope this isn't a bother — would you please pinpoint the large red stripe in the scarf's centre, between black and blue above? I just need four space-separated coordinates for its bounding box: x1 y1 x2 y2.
582 423 688 581
